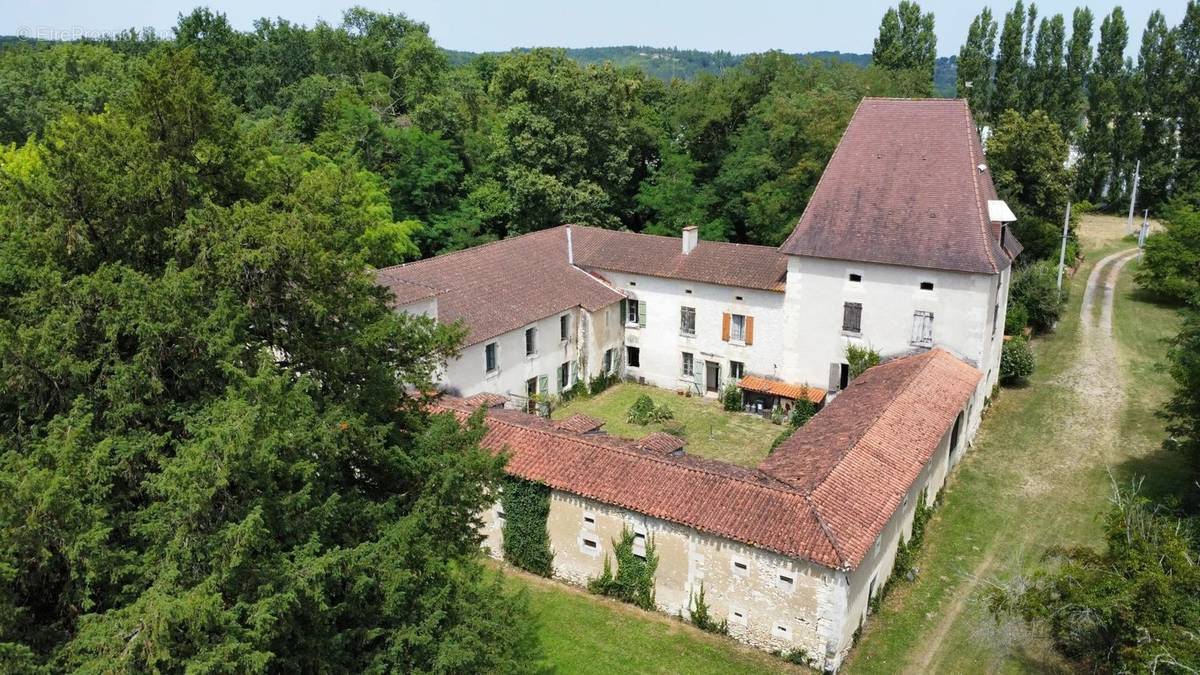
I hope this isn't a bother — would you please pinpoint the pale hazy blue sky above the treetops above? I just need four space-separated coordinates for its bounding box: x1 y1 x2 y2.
0 0 1186 56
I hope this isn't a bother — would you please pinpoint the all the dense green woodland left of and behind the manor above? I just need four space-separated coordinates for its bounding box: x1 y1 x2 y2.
0 0 1200 673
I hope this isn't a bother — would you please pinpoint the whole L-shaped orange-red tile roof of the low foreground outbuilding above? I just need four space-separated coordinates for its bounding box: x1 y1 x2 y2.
437 350 980 569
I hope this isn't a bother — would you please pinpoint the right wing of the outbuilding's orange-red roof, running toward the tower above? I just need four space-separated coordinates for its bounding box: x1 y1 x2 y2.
758 348 982 567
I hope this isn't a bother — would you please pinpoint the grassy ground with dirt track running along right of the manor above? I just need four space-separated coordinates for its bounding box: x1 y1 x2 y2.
848 216 1186 673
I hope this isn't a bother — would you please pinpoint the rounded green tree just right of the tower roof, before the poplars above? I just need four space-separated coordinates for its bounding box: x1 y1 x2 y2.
988 110 1070 259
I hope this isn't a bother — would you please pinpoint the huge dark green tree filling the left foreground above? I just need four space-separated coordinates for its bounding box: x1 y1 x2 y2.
0 48 536 671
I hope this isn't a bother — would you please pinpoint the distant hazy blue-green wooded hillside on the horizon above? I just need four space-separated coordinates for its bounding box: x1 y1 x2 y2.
448 46 956 96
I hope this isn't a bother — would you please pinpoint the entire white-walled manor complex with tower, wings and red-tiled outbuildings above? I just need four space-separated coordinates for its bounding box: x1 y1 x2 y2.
378 98 1020 669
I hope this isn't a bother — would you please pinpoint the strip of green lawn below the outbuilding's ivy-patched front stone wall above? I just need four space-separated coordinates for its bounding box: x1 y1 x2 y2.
504 568 810 675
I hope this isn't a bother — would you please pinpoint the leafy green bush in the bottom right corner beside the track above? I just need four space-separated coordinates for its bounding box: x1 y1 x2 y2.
990 486 1200 673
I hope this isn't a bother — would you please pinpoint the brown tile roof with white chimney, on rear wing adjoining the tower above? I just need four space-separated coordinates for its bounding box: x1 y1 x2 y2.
572 225 787 292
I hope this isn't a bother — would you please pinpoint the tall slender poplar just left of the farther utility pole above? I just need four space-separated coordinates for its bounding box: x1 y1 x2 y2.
1076 7 1132 202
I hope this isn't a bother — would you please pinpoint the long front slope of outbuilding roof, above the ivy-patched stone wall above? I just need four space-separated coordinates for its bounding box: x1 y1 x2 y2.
436 396 841 568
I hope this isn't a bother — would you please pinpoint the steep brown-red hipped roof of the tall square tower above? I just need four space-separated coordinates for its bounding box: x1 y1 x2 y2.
780 98 1013 274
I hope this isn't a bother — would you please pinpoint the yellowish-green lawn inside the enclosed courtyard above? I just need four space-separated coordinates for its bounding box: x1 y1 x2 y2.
552 383 784 466
